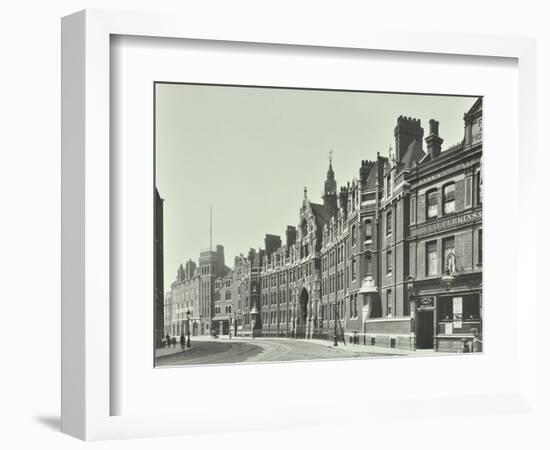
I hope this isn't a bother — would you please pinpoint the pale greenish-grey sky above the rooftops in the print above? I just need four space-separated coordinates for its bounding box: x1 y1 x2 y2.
156 84 476 290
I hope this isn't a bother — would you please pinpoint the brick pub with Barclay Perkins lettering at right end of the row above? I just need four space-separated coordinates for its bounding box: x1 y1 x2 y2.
408 99 483 351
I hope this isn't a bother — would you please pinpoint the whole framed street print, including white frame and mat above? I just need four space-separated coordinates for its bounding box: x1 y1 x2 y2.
62 11 537 442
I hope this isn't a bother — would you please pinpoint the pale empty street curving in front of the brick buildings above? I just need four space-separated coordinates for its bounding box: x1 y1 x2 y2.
156 337 406 366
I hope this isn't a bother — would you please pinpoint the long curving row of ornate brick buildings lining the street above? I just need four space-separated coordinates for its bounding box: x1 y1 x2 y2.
163 99 482 351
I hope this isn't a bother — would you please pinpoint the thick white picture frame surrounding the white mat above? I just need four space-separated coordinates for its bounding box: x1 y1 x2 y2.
62 10 541 440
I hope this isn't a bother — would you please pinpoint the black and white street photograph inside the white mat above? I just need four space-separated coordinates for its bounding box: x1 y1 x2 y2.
154 82 483 367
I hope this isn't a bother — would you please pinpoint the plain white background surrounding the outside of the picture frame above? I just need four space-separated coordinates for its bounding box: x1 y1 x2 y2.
0 0 550 449
